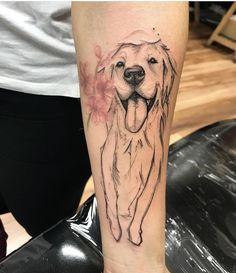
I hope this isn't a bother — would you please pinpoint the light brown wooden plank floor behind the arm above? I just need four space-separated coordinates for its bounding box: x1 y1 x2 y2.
1 25 236 254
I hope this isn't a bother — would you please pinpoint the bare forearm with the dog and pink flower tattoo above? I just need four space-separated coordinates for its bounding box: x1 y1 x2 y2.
72 2 188 273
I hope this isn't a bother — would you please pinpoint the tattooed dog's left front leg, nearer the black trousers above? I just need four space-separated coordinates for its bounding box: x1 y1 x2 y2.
101 129 122 241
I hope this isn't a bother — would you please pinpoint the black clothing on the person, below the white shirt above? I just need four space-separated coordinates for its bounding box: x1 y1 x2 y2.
0 88 91 236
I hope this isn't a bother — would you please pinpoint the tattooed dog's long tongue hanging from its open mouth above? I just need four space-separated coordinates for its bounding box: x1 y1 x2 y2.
125 97 147 133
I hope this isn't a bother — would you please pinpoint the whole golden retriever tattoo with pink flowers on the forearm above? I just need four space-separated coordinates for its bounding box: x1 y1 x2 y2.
80 30 176 246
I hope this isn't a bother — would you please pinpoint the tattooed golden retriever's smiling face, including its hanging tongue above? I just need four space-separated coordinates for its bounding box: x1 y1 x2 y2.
108 42 173 133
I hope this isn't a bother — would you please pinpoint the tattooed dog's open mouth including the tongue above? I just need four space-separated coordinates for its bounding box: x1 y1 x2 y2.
120 88 157 133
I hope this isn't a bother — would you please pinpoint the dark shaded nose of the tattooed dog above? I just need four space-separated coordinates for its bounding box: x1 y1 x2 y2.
124 65 145 85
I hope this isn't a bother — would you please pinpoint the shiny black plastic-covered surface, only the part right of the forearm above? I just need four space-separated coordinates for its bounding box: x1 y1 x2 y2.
166 120 236 273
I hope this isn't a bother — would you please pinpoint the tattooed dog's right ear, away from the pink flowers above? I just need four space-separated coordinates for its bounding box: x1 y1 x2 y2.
160 44 176 116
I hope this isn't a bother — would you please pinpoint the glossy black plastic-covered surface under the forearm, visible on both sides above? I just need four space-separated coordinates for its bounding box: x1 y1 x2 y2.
0 120 236 273
